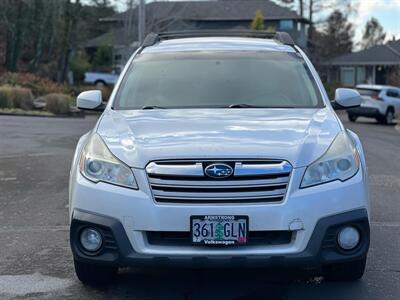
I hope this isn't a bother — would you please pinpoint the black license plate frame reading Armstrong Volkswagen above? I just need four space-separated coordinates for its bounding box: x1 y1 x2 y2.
190 215 249 246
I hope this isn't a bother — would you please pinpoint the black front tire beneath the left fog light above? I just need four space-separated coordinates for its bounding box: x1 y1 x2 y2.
74 260 118 286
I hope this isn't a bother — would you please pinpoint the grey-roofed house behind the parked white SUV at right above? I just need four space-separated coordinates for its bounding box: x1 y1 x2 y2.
323 40 400 87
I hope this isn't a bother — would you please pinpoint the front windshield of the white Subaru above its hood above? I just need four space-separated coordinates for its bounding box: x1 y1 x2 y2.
113 51 324 109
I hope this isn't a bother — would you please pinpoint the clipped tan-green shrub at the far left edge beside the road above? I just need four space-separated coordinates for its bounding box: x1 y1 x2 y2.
0 86 33 110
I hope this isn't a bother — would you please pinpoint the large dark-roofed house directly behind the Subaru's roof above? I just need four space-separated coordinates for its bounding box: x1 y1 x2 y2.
85 0 309 64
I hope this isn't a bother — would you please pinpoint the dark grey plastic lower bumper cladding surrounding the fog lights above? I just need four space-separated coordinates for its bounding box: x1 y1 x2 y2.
70 209 370 268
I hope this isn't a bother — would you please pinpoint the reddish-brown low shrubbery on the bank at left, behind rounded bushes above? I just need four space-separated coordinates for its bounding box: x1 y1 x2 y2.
0 73 69 97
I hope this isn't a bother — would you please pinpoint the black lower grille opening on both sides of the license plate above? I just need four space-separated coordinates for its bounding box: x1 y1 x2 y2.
146 230 293 247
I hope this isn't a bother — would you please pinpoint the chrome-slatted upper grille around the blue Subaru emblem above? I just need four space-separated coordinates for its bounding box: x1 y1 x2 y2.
146 160 292 204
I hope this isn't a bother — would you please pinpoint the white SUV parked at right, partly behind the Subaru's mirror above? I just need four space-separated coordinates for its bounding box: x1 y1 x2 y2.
347 84 400 124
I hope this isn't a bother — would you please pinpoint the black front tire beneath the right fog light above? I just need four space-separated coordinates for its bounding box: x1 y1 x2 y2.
323 258 367 281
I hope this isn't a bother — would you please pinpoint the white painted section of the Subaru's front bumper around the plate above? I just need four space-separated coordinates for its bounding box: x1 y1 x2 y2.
70 162 369 257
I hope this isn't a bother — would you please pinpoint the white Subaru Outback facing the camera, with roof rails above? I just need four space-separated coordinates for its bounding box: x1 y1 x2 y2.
69 31 370 284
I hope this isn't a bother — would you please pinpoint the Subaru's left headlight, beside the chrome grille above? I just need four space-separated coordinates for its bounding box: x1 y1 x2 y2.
79 134 138 189
